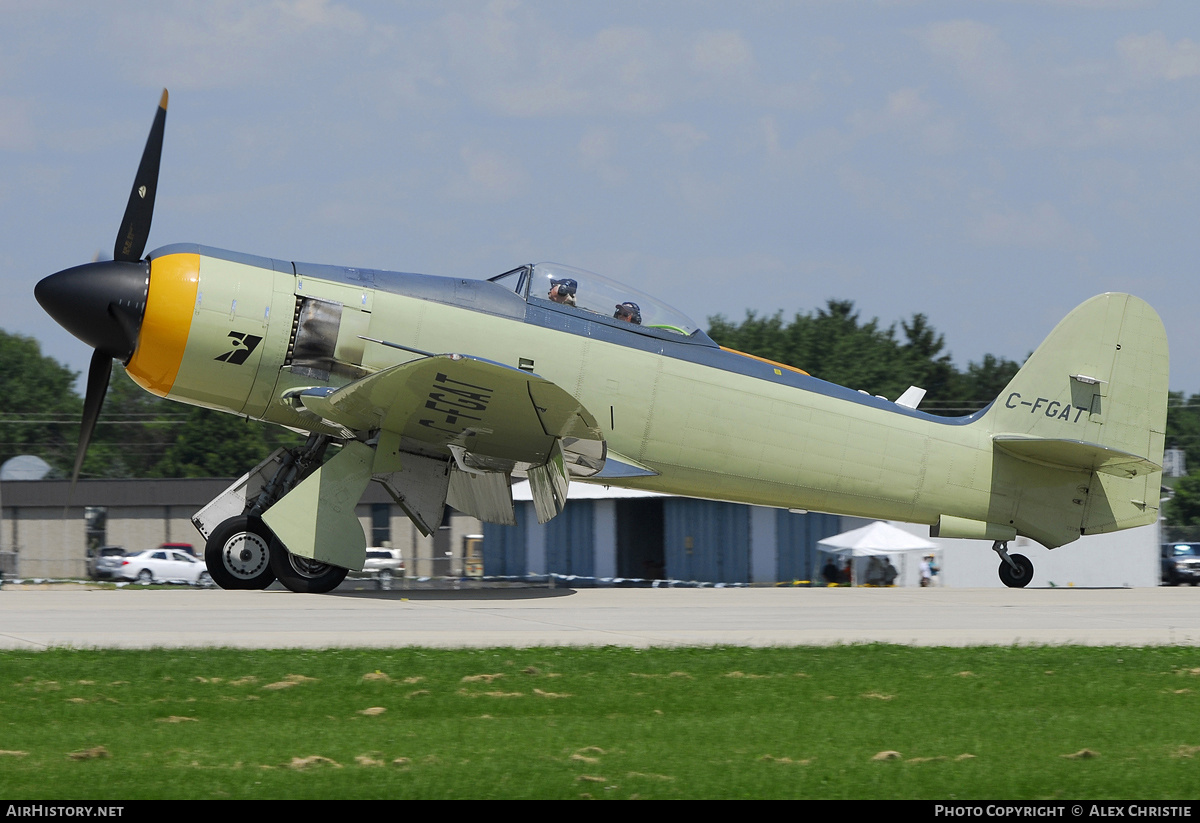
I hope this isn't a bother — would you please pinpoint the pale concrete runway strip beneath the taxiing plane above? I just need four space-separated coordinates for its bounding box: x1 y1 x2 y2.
0 585 1200 649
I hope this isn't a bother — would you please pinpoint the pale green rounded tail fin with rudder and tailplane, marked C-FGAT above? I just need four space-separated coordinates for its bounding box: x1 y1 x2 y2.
982 294 1168 547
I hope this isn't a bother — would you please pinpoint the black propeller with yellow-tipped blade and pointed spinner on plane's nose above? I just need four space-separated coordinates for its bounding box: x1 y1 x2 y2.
34 89 167 488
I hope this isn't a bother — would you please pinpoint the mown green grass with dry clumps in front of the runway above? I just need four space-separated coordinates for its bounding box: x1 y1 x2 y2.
0 645 1200 800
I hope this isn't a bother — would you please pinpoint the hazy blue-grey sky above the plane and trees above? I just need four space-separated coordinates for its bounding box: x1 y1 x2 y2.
0 0 1200 395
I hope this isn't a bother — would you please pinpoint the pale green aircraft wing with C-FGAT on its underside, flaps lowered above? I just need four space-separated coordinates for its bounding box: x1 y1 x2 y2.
284 354 607 522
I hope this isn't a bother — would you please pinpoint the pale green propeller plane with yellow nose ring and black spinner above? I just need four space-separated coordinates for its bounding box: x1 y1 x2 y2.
36 91 1168 591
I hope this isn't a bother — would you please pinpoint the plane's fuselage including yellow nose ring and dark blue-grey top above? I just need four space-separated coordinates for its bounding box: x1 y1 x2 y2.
127 246 1086 554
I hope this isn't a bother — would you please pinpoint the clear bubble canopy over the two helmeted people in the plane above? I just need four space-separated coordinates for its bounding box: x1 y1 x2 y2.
492 263 700 336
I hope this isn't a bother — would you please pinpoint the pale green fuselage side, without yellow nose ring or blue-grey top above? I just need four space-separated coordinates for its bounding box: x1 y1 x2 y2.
157 249 1160 547
